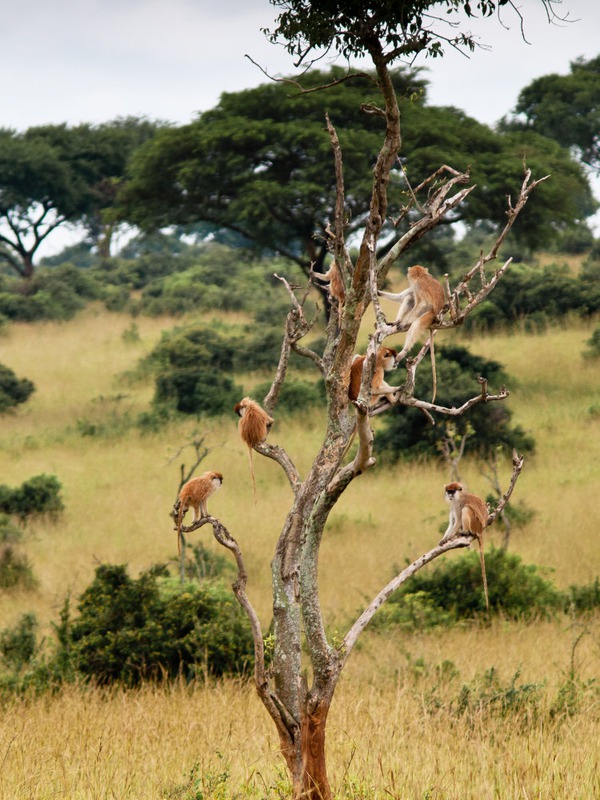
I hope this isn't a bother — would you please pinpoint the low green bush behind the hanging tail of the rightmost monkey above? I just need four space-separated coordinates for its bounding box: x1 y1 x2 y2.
374 545 566 629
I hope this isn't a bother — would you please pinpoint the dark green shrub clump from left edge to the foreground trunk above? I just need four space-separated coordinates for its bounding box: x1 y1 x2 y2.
0 564 253 691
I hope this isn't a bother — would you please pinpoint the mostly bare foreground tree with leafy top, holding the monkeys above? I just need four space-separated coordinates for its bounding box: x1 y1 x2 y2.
176 0 551 800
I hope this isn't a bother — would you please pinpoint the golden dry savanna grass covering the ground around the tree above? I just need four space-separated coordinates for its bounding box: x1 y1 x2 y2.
0 306 600 800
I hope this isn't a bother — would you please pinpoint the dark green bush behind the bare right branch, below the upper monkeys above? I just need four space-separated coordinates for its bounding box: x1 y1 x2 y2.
376 345 535 463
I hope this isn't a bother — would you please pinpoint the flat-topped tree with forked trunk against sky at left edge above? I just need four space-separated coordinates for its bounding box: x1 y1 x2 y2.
0 118 155 278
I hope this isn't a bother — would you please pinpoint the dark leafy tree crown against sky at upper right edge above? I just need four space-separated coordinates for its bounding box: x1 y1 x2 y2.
503 56 600 173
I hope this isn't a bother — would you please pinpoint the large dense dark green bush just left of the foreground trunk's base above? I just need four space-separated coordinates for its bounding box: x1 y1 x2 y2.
59 564 253 686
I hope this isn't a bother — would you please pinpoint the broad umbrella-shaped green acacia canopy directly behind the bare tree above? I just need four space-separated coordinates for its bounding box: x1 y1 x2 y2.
120 68 595 271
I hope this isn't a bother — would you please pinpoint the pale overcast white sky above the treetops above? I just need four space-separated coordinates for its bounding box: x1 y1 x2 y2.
0 0 600 252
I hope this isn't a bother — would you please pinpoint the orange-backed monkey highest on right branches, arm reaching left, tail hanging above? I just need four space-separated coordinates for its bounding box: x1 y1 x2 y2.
378 264 446 403
